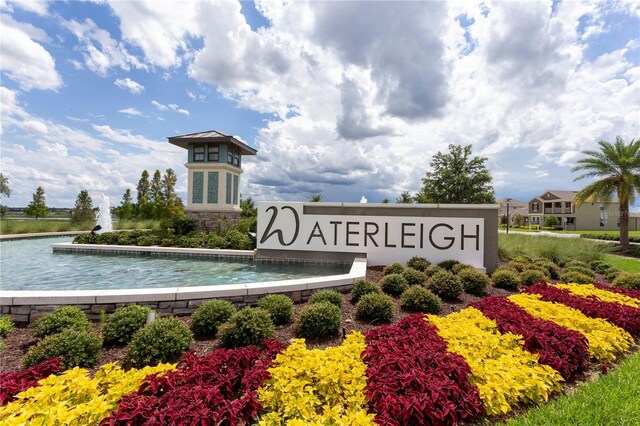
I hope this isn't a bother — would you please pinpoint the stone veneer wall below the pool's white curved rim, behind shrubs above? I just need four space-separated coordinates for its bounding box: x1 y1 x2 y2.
0 284 353 323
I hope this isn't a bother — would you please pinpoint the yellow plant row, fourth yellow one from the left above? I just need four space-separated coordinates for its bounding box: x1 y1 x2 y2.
509 287 633 362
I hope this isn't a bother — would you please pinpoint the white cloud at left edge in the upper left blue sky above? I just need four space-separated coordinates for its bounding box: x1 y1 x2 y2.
0 20 62 91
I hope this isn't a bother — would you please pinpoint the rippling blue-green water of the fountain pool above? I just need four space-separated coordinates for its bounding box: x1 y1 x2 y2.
0 237 349 290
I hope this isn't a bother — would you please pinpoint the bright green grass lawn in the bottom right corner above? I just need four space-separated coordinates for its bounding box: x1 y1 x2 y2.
507 352 640 426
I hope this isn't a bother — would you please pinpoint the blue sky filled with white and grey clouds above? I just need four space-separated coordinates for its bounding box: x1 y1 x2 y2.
0 0 640 207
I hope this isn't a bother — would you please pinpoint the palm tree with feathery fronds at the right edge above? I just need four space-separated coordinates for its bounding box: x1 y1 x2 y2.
573 136 640 248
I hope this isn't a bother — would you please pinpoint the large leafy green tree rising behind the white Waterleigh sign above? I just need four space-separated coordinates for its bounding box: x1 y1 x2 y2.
416 144 496 204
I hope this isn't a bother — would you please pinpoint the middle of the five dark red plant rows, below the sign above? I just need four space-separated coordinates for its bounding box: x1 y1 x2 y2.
364 314 484 426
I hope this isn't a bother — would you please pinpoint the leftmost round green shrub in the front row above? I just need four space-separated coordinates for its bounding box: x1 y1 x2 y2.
22 328 102 369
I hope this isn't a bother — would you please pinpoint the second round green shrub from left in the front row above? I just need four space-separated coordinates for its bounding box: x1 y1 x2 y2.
128 317 193 367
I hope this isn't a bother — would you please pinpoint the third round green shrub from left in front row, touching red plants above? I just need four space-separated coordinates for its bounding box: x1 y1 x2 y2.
218 307 274 348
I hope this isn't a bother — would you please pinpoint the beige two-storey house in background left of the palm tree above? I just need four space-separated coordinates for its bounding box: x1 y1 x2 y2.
528 190 640 231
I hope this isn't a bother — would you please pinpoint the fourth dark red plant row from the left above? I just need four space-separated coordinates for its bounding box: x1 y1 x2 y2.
469 296 589 380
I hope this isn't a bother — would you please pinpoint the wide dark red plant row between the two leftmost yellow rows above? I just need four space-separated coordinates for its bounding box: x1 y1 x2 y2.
101 340 284 425
